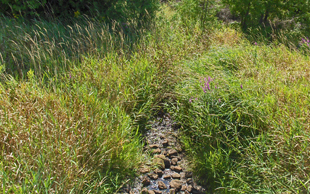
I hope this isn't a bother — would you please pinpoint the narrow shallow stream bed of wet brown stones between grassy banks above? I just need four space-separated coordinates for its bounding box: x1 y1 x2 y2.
120 114 206 194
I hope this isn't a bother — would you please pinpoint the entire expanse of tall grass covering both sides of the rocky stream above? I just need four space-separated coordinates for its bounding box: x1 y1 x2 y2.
0 1 310 193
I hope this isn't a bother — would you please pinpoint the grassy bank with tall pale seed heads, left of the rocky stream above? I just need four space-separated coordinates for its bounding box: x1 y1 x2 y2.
0 5 208 193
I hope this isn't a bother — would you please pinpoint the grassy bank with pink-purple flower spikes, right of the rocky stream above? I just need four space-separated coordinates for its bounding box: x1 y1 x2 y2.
173 28 310 193
